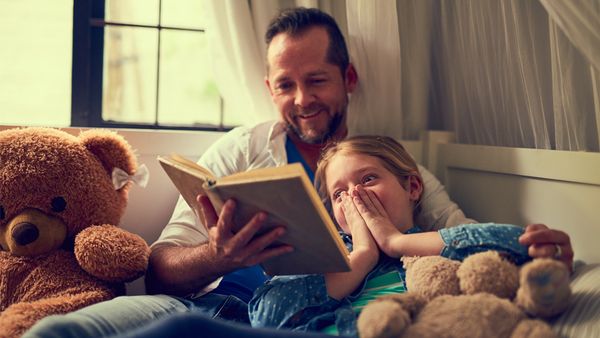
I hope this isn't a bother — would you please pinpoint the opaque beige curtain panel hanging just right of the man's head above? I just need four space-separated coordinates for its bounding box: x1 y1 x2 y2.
346 0 433 138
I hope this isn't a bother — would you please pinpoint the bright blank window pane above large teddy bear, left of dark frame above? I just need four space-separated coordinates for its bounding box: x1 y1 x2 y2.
0 0 73 127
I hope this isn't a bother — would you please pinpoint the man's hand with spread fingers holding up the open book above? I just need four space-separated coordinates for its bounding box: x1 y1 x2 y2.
197 195 293 270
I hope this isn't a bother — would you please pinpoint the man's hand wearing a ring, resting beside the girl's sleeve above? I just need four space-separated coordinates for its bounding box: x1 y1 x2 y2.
519 224 573 271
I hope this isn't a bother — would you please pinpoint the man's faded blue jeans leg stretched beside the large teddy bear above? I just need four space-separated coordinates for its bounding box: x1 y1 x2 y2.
22 293 249 338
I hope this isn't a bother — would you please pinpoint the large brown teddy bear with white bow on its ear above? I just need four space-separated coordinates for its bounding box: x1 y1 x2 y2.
0 128 149 338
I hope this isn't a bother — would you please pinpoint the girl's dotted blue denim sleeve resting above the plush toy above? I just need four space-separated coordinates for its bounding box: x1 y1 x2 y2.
439 223 531 265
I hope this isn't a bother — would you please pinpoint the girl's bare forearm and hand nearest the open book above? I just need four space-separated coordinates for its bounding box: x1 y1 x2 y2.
325 193 379 300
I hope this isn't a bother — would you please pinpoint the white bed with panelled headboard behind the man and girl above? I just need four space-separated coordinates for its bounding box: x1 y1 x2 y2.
0 126 600 337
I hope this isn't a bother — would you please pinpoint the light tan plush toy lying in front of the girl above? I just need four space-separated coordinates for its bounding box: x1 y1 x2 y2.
357 251 571 338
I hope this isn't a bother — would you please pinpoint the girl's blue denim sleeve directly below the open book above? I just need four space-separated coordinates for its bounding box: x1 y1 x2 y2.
248 275 340 329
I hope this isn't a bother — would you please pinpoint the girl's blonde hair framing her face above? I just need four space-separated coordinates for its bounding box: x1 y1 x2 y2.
315 135 424 216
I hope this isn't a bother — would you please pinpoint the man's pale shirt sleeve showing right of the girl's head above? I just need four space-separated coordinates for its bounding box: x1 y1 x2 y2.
416 166 475 230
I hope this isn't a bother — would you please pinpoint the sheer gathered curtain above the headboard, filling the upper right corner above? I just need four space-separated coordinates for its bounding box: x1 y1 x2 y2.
432 0 600 151
